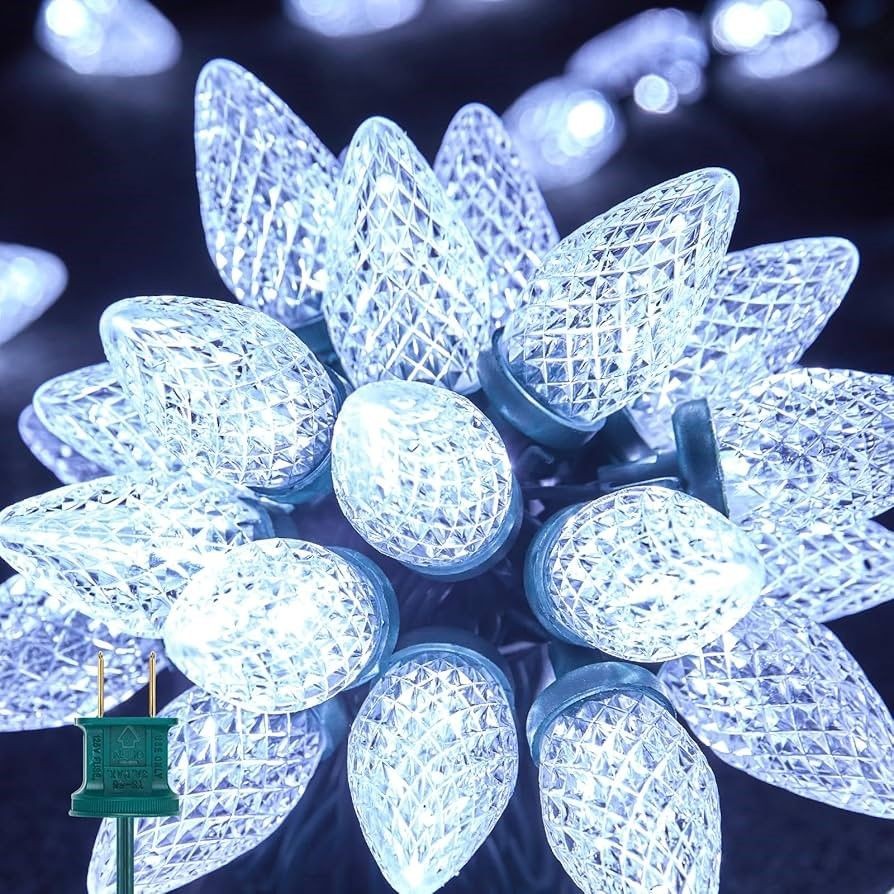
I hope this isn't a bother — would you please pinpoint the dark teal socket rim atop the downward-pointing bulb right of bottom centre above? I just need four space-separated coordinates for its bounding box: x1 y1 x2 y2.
525 661 674 765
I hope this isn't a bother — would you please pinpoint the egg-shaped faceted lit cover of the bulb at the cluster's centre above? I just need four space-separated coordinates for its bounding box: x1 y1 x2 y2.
332 382 514 568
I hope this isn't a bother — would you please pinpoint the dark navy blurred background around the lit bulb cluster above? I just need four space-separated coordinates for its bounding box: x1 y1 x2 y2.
0 0 894 894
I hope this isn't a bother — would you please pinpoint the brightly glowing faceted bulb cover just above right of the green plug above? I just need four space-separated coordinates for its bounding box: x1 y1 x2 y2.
164 539 388 712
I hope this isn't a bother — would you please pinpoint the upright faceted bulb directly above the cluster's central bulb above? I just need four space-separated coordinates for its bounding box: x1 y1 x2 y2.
323 118 490 392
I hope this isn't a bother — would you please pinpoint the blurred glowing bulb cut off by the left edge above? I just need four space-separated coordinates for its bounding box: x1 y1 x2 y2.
0 243 68 344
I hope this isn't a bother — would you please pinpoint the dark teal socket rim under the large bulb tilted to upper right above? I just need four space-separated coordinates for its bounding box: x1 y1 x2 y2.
478 329 603 450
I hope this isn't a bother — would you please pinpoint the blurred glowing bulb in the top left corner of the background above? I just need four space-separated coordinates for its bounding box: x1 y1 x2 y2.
35 0 180 77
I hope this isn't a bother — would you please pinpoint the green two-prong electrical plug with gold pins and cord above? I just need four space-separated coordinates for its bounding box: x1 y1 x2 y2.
69 652 180 894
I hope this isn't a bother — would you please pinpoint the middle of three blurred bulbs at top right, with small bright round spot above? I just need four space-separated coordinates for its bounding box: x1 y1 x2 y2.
568 9 710 114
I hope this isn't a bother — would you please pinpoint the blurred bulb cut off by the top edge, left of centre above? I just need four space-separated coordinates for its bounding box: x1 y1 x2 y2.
284 0 423 37
